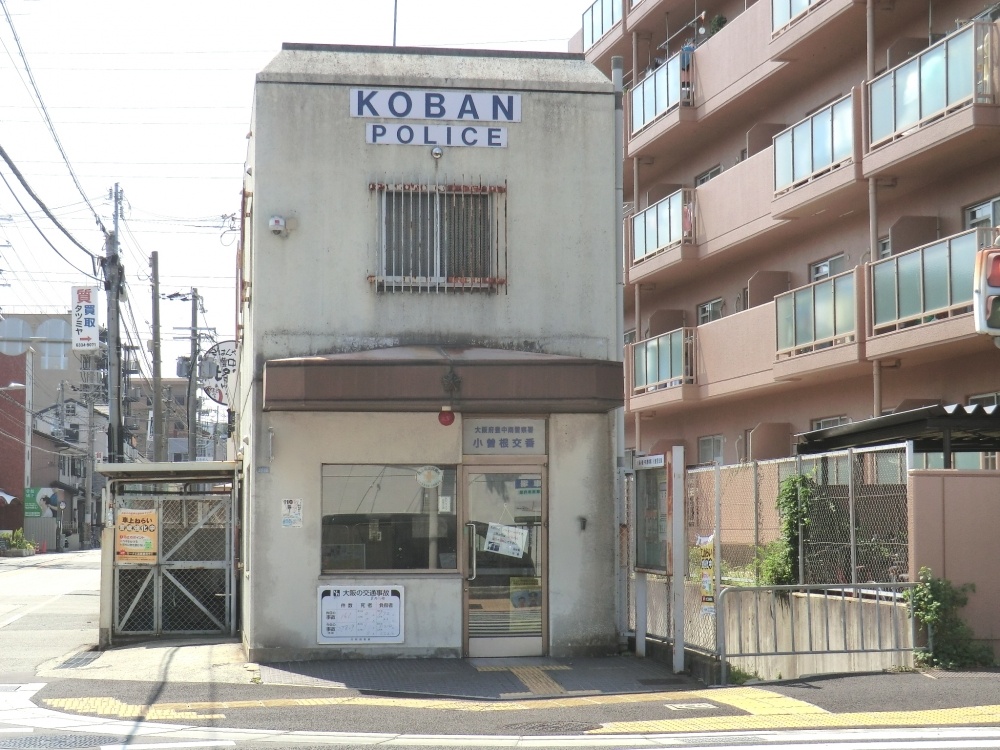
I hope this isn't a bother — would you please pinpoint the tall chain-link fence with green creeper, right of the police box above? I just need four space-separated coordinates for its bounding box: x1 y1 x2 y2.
629 446 910 652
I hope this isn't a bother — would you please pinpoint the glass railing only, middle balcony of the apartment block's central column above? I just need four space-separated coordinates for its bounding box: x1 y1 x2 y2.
774 94 854 193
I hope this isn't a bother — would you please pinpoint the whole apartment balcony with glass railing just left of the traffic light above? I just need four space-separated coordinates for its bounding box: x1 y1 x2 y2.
868 229 992 359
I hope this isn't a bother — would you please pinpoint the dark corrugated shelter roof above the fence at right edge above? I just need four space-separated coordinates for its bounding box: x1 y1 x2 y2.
796 404 1000 458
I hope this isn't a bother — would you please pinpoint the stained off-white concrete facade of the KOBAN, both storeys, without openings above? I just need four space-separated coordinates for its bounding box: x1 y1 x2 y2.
237 45 621 660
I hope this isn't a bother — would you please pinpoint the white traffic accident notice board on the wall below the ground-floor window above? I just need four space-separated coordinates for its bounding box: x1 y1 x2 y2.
317 583 403 643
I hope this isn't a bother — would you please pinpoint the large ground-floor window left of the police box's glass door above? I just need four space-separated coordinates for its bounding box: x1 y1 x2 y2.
321 465 458 573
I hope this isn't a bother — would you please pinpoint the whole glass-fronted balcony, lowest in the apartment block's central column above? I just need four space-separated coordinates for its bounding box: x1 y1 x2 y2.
774 267 864 380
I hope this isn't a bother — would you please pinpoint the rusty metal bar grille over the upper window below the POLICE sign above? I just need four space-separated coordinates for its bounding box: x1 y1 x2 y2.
369 183 507 293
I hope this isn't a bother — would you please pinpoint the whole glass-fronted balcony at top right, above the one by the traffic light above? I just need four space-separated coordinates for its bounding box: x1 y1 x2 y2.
864 22 1000 177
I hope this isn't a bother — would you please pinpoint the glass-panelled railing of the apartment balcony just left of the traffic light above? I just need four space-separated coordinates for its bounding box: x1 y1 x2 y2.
870 229 992 336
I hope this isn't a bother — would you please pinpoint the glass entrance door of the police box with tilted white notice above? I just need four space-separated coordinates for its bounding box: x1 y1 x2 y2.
464 466 547 656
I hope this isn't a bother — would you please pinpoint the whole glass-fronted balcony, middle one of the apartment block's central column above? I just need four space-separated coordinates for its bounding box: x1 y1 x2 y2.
771 89 867 219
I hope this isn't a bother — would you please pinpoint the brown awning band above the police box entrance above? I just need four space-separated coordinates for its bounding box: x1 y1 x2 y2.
264 346 624 414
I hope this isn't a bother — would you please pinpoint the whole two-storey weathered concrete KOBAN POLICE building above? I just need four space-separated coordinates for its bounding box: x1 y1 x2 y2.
237 44 623 660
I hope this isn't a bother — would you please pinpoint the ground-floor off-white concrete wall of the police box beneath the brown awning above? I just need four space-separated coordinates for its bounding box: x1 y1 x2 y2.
243 412 617 660
